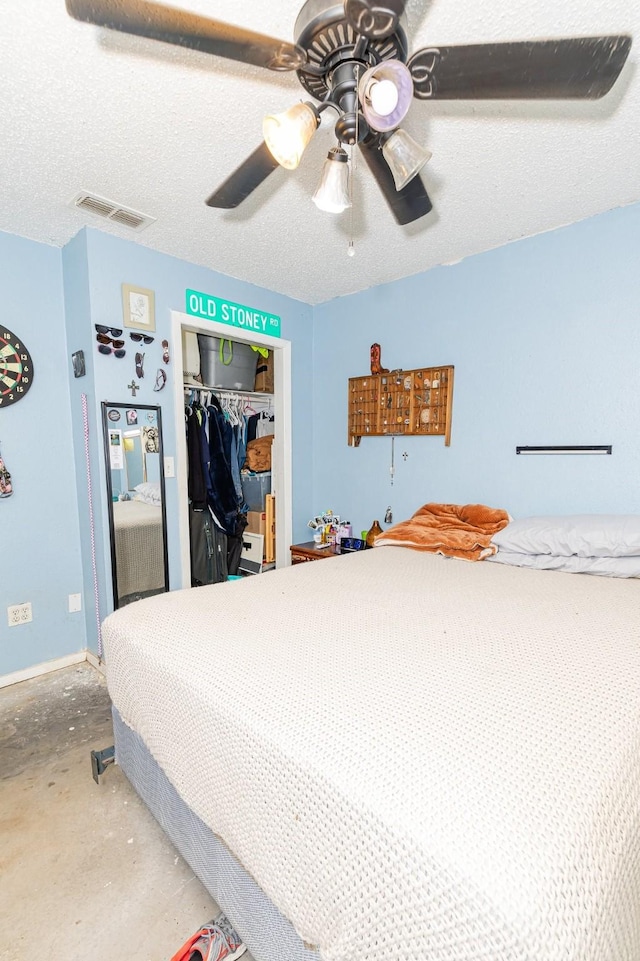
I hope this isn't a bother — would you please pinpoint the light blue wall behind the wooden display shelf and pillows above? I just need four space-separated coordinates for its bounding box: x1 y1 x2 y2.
314 205 640 530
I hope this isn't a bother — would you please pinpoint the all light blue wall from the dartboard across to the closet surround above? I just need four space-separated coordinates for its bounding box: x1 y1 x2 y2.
0 230 313 676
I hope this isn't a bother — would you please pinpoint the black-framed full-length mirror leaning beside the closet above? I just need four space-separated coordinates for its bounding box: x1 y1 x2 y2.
102 401 169 608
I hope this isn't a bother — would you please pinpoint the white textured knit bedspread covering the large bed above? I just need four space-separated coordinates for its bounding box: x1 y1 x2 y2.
104 547 640 961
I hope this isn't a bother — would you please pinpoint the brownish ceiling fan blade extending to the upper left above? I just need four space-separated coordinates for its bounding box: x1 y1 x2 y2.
66 0 307 70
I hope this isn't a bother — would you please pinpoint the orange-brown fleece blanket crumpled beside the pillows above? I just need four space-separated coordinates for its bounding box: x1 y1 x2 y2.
375 504 509 561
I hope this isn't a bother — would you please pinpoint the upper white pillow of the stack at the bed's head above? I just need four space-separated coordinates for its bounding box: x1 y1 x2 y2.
491 514 640 557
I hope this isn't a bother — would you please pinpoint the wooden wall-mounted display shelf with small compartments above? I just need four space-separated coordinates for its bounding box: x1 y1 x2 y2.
348 366 453 447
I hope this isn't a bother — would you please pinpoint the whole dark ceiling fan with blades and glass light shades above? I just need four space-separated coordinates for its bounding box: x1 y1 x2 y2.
66 0 631 224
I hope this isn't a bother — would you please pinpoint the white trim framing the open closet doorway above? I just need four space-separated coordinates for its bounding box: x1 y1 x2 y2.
171 310 293 587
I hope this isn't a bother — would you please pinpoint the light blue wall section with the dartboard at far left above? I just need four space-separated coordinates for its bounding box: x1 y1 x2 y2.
0 233 86 674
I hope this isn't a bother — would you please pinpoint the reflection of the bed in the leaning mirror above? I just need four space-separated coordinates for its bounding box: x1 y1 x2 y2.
113 497 165 604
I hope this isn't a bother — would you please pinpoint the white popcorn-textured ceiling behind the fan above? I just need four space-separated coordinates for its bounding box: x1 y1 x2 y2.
0 0 640 304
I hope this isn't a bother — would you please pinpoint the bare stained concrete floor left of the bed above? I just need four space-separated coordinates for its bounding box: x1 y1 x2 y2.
0 663 222 961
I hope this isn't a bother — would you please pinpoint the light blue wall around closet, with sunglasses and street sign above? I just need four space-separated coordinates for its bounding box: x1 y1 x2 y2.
83 230 313 632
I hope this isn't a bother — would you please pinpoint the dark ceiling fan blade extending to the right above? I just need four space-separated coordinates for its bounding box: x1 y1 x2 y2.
407 35 631 100
